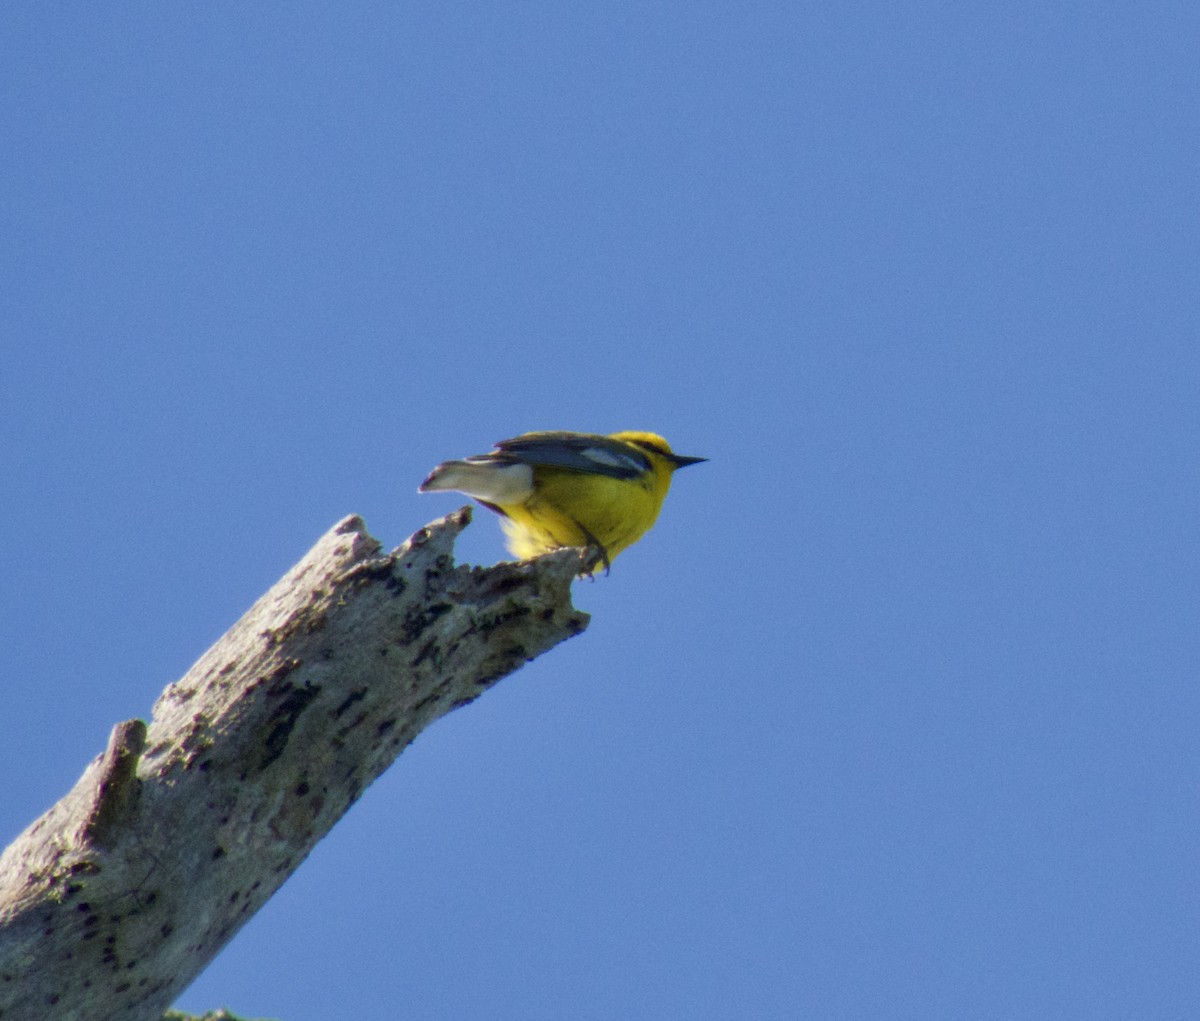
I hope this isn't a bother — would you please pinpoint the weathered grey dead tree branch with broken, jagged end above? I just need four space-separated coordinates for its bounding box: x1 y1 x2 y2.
0 509 588 1021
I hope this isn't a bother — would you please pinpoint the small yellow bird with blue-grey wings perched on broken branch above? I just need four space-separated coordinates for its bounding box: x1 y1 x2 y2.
418 431 708 577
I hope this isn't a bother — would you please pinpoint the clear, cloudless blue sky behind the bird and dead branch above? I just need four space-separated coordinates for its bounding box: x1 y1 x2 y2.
0 0 1200 1021
